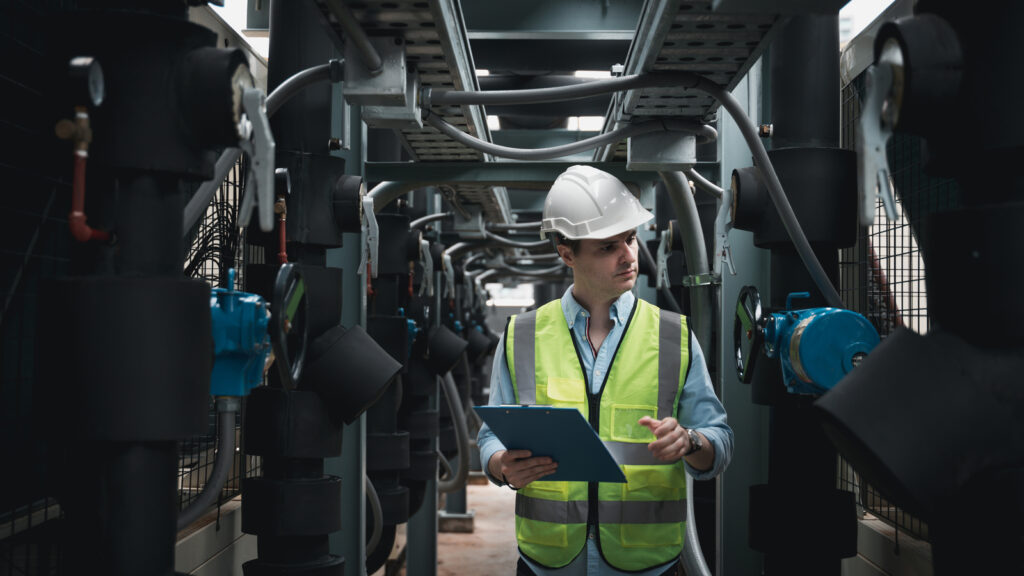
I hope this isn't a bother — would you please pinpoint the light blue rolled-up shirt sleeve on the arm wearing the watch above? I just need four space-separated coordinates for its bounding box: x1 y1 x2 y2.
678 338 733 480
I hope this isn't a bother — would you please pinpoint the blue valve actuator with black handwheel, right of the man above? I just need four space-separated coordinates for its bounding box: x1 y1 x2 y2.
735 287 880 396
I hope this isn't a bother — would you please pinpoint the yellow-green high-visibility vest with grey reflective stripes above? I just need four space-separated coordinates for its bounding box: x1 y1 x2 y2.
505 298 689 571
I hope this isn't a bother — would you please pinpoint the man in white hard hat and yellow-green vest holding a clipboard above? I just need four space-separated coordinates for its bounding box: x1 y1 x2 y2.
477 166 733 576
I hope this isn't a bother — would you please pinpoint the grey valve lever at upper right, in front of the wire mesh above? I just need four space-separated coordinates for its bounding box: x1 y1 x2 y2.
856 63 897 227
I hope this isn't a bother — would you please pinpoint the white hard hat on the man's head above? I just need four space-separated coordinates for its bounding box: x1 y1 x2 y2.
541 165 654 240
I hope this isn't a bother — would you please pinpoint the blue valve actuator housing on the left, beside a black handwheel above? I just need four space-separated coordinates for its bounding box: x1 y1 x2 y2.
210 269 270 396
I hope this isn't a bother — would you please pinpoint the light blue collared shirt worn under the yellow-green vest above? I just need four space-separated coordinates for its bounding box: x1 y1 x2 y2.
476 286 733 576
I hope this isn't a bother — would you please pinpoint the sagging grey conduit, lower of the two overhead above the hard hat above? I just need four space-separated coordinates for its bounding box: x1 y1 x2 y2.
424 110 718 160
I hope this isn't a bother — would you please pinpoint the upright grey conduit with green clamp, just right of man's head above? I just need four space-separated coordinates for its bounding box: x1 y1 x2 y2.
658 170 712 351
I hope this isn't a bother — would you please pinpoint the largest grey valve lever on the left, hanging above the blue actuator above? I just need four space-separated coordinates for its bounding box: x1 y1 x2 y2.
238 88 276 232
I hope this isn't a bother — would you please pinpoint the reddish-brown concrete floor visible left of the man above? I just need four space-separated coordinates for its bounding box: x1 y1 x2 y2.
372 477 519 576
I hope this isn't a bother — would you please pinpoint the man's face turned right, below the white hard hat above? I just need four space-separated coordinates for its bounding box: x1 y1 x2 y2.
558 230 637 299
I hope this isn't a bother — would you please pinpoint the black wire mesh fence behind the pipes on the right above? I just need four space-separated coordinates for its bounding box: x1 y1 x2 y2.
839 69 958 540
